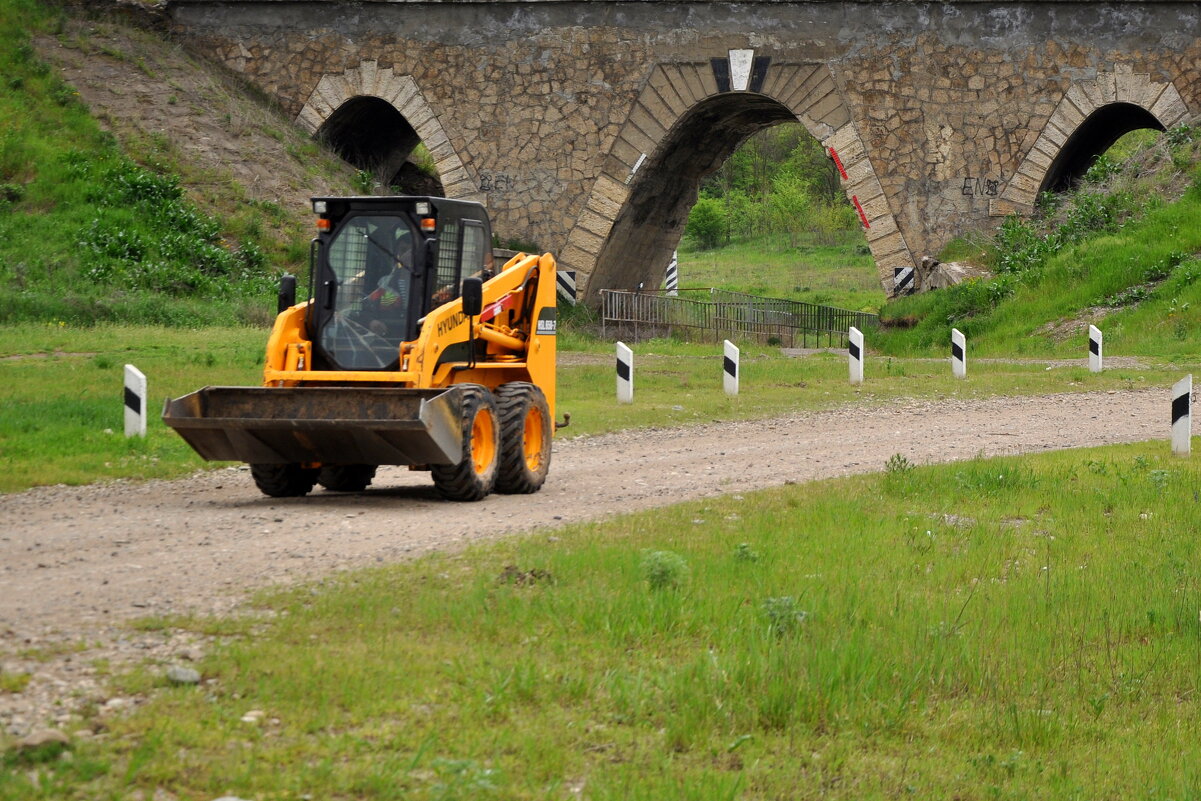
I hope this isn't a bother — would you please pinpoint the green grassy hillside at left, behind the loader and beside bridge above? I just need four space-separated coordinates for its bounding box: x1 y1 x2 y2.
0 0 350 325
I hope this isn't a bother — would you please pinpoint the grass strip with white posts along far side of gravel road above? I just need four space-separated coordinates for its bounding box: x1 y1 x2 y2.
0 323 1201 492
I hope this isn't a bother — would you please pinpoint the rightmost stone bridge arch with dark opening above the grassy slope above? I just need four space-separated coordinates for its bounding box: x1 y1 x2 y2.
990 67 1189 216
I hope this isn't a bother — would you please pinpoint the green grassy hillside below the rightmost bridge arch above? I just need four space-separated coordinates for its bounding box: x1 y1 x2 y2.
874 127 1201 359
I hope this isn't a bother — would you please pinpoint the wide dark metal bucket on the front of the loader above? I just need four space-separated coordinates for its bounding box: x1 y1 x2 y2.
162 387 462 465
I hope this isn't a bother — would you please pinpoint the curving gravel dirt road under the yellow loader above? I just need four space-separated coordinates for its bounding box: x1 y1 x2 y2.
0 390 1169 733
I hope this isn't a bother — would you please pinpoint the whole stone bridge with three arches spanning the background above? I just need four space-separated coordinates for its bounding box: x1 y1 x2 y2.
167 0 1201 299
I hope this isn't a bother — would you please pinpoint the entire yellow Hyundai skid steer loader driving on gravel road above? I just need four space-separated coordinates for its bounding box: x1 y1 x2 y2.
162 197 566 501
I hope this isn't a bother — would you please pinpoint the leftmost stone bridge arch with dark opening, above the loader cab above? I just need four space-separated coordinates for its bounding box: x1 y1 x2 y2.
297 61 485 203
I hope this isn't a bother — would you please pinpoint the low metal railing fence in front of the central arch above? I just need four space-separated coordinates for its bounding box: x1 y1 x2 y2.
601 288 879 347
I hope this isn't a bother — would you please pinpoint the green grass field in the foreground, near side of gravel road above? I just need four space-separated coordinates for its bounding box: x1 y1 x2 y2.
0 443 1201 801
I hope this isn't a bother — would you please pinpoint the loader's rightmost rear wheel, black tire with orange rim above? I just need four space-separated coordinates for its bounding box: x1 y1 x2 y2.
496 381 555 495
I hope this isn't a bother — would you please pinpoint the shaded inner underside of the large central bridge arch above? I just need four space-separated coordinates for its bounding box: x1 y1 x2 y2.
588 92 797 299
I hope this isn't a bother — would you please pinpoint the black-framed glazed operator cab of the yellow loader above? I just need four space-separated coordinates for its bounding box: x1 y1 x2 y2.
309 197 492 371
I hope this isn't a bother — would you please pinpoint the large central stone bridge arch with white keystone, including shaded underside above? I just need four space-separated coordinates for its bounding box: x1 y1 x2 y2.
560 50 913 303
